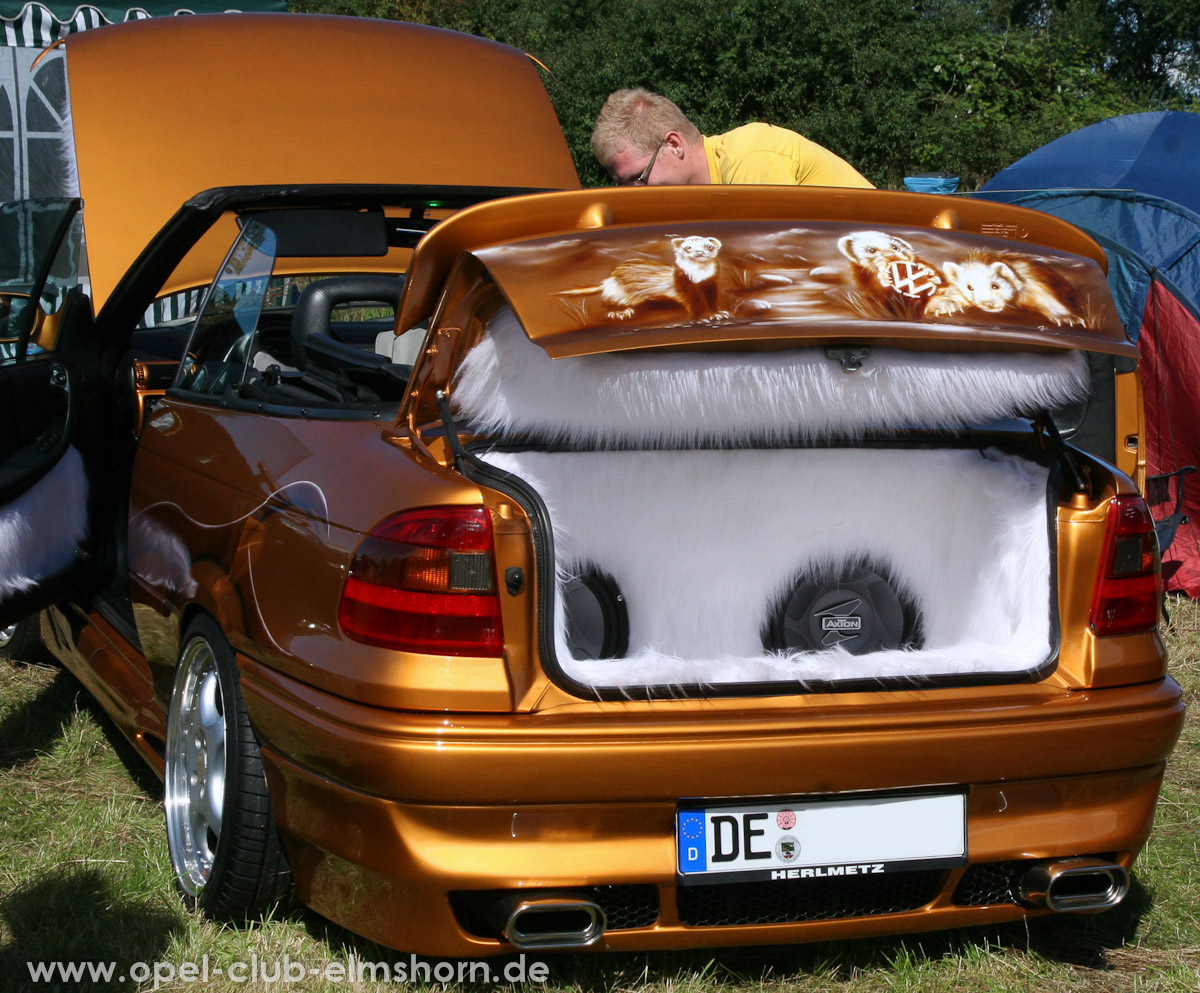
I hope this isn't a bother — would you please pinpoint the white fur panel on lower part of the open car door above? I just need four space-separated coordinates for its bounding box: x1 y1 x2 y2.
0 447 88 597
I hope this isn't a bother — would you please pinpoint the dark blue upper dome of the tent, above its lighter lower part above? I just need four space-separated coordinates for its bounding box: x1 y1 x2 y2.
980 110 1200 213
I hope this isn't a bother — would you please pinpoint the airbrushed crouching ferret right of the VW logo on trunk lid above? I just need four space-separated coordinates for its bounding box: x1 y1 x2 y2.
925 251 1084 326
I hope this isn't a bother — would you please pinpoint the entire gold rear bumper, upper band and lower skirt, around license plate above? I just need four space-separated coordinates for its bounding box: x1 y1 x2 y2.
242 660 1183 956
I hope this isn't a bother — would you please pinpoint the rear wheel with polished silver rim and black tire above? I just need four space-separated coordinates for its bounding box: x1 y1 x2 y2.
163 616 292 922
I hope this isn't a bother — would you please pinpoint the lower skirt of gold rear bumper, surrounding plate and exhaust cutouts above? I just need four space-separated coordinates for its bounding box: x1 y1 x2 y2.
270 756 1162 957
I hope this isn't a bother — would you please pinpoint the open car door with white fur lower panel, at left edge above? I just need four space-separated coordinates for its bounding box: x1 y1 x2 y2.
0 199 95 625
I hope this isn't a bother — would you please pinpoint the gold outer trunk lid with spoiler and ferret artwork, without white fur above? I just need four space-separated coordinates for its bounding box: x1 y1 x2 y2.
402 187 1135 357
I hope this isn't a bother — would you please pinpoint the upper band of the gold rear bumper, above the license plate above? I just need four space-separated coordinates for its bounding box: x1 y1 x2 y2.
242 662 1183 805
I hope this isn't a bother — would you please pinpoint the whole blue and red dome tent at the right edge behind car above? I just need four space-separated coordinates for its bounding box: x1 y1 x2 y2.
977 113 1200 597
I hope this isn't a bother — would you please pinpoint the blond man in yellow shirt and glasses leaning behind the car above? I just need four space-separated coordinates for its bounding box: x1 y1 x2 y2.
592 90 874 189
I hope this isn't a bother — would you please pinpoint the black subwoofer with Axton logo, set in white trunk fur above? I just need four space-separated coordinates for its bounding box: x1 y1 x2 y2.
763 562 923 655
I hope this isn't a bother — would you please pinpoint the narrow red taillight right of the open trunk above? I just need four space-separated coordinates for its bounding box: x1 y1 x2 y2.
1092 495 1163 636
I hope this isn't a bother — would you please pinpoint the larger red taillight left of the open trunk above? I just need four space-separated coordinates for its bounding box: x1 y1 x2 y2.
337 507 504 656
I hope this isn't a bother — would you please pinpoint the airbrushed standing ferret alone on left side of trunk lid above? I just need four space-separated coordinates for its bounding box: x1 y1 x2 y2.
559 235 724 320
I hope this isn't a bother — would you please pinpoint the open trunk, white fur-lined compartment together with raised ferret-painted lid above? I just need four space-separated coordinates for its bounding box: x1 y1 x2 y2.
401 189 1130 696
